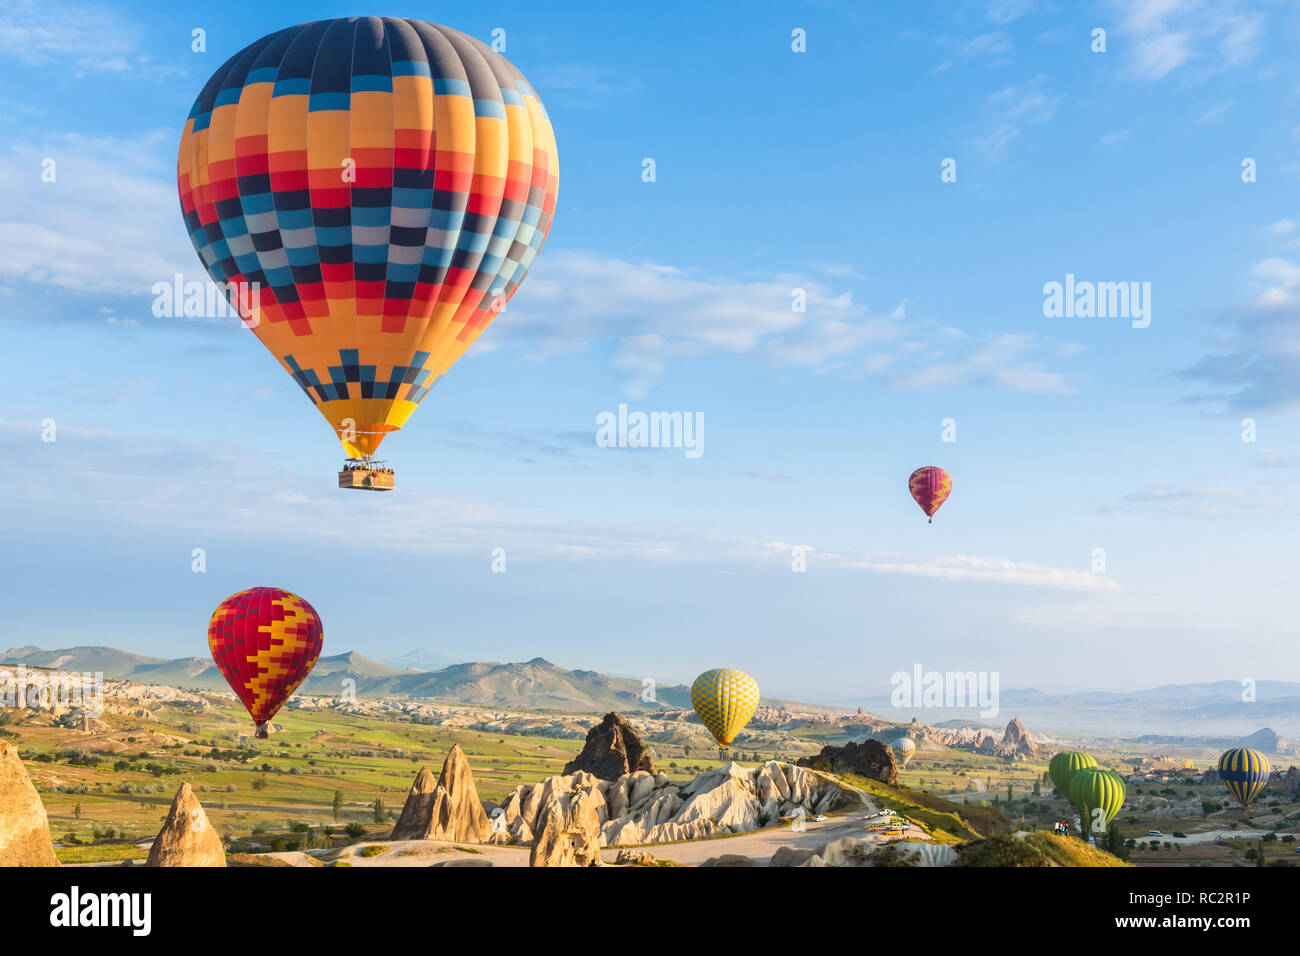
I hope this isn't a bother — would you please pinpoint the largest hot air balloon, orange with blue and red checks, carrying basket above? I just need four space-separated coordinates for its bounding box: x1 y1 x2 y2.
177 17 559 488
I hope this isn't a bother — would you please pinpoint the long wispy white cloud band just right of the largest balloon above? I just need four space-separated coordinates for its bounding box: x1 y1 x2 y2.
485 251 1066 398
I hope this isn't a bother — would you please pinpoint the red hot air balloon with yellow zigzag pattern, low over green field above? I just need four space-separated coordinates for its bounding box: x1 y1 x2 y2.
208 588 324 737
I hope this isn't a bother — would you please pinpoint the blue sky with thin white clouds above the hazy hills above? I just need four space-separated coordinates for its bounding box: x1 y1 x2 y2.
0 0 1300 702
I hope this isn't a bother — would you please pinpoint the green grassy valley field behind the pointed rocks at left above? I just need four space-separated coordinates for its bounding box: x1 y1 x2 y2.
0 704 759 862
